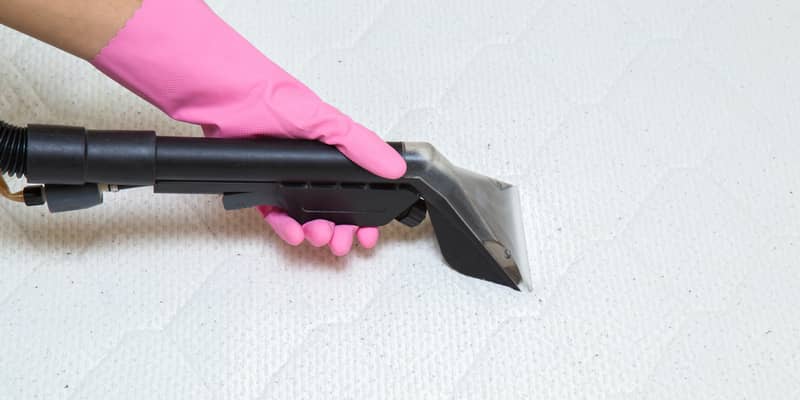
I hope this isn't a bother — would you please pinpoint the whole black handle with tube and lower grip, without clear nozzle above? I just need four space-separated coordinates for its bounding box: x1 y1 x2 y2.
27 125 425 226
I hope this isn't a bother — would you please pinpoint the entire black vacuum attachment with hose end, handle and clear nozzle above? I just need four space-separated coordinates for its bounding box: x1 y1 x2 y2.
0 122 530 290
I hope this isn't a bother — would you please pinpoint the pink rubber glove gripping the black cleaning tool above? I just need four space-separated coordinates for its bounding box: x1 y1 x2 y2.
92 0 406 255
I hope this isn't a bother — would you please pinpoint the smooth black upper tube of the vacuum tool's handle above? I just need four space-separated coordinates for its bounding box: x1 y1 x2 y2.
27 125 403 186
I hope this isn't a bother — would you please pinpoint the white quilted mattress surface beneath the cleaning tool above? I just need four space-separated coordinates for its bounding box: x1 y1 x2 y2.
0 0 800 399
